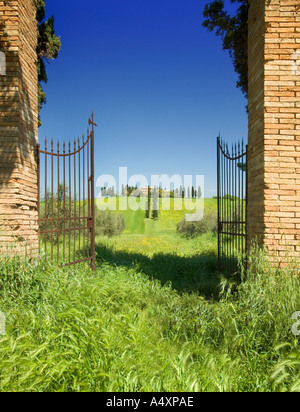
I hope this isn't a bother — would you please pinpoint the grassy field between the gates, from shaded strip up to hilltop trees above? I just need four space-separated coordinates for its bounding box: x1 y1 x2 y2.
96 197 218 296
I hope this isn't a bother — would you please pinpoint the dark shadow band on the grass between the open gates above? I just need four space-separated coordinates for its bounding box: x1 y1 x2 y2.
96 243 220 299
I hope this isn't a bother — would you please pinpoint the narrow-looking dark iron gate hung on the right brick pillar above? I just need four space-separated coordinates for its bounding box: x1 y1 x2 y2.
217 137 247 274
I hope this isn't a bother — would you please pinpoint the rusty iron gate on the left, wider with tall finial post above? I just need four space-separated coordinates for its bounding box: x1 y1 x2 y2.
37 114 97 270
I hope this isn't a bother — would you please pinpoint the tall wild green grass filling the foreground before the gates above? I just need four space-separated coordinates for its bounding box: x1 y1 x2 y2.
0 248 300 392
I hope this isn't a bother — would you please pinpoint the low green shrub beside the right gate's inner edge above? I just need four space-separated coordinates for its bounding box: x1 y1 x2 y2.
177 211 218 236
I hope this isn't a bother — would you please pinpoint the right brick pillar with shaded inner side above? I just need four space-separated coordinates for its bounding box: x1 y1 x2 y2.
248 0 300 260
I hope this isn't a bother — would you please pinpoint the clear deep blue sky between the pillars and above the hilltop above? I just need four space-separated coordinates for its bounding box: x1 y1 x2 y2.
39 0 248 197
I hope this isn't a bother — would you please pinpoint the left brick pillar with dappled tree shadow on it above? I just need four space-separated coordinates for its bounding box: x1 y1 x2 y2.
0 0 38 251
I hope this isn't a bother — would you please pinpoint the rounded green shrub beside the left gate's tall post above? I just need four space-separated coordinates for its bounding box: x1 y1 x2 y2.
95 209 125 237
